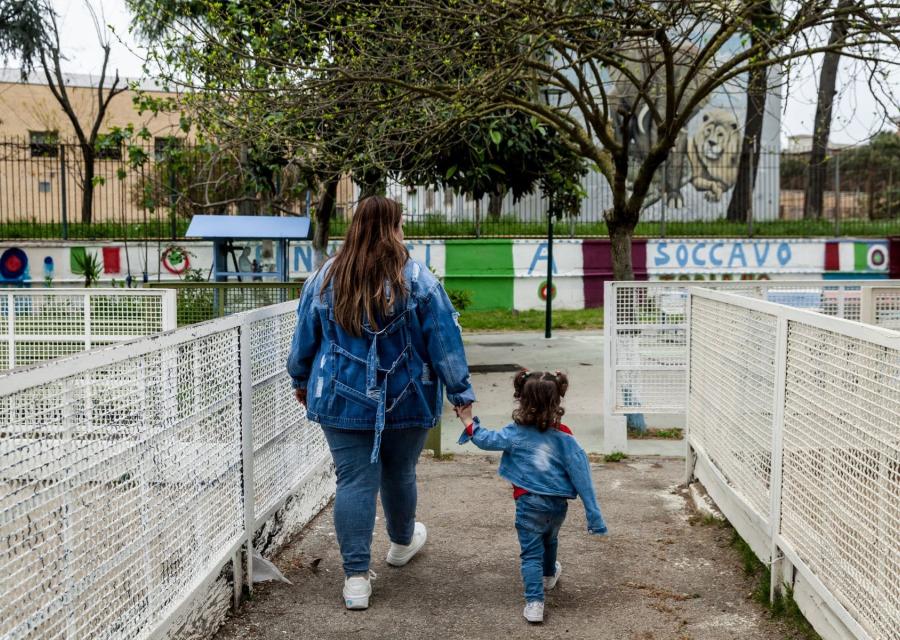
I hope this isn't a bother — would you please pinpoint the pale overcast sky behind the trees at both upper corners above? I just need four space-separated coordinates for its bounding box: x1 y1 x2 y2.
28 0 900 144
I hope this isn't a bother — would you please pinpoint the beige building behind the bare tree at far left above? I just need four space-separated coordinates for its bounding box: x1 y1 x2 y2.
0 69 186 224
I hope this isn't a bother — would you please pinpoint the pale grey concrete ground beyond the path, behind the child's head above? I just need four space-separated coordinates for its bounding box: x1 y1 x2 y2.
441 331 684 456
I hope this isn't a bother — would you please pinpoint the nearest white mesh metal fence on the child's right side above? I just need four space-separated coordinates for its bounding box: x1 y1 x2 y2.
687 289 900 640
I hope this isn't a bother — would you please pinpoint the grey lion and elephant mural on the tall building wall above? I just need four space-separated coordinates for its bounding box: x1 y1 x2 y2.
589 36 779 221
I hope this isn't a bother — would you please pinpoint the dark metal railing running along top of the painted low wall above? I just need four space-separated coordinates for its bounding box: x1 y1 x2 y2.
0 136 900 240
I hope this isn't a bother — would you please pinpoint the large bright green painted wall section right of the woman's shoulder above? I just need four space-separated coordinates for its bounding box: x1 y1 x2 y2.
444 240 513 310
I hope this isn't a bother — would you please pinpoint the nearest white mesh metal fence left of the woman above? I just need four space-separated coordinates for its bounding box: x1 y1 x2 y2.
0 302 330 640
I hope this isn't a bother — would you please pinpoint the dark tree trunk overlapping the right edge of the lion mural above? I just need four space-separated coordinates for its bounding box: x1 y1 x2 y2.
721 62 768 222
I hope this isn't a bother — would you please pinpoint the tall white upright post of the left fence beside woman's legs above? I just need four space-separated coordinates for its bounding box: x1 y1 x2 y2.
234 320 256 594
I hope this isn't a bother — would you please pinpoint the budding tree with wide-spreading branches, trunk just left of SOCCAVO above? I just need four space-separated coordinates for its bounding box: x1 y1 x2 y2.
304 0 900 279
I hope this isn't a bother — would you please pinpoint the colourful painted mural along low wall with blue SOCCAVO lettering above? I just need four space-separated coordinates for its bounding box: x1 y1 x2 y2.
0 238 900 310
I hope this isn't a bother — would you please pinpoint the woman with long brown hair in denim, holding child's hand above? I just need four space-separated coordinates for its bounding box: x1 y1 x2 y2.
287 197 475 609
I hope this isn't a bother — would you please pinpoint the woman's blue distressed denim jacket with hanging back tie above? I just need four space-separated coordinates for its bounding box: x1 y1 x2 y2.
287 260 475 462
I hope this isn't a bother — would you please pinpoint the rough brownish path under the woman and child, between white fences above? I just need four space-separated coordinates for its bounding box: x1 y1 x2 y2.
217 455 793 640
